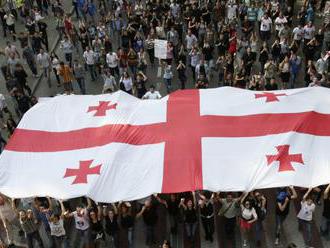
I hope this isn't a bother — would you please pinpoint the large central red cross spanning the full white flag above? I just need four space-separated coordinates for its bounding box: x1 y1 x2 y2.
5 90 330 193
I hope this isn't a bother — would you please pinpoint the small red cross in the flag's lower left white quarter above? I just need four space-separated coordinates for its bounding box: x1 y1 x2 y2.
63 160 102 184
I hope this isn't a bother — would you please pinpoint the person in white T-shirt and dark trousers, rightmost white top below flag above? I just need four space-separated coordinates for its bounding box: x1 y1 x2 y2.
297 188 315 247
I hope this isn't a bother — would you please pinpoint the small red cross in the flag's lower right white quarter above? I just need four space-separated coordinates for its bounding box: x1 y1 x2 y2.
266 145 304 172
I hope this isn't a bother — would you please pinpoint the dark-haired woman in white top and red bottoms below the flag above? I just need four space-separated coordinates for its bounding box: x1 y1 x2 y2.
240 192 258 247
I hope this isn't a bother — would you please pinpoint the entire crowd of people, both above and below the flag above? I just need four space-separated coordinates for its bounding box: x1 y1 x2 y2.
0 0 330 247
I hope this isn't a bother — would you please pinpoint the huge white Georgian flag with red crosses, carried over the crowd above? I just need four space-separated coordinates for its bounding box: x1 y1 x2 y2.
0 87 330 202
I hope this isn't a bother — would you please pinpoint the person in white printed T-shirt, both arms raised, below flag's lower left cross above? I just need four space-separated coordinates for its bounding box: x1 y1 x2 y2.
60 198 92 247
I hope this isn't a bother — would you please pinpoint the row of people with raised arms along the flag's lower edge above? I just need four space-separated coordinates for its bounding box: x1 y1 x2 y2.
0 184 330 248
